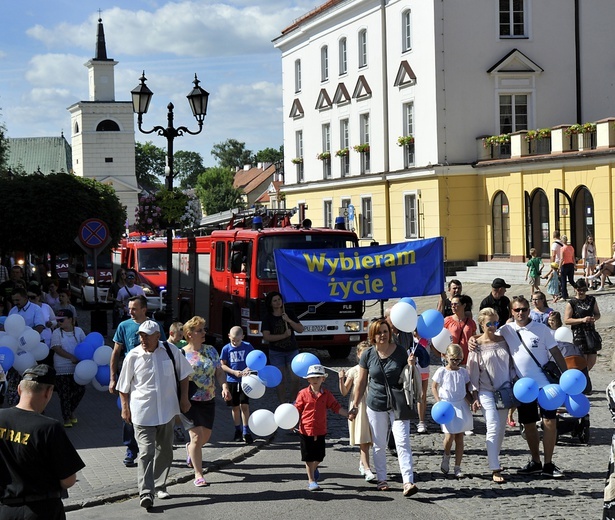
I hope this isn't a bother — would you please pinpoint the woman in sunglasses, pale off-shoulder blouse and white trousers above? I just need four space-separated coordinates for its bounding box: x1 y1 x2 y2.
468 307 515 484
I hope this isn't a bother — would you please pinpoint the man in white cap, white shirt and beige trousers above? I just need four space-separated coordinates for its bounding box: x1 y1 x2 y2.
117 320 193 509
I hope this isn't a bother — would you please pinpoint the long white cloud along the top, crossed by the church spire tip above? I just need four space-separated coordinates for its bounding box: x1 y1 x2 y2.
27 0 307 58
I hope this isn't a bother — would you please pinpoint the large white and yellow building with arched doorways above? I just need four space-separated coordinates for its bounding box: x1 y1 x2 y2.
274 0 615 263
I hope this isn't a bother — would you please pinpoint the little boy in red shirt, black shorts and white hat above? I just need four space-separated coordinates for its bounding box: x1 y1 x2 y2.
295 365 357 491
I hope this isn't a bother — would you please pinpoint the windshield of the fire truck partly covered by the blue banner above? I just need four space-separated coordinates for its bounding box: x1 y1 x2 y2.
256 233 357 280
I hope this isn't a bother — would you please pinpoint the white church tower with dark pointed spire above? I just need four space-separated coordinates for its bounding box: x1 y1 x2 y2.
68 18 140 223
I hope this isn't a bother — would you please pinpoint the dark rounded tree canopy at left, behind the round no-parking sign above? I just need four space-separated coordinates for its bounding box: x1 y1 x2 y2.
0 173 126 254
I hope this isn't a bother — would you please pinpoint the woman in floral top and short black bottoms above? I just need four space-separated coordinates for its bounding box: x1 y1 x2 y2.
183 316 231 487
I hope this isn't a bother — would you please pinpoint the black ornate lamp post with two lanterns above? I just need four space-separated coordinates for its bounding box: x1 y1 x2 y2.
131 71 209 328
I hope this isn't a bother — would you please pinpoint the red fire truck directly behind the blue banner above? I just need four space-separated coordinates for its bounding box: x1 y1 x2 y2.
173 210 368 358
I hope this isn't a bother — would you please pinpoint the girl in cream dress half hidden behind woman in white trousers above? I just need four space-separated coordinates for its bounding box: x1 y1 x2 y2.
339 341 376 482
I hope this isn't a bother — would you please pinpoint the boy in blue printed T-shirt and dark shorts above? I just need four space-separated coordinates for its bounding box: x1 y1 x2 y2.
220 326 255 444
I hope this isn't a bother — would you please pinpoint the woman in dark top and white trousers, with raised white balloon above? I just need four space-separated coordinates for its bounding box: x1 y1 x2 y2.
352 316 422 497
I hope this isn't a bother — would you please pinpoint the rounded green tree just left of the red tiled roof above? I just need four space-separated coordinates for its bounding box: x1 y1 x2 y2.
196 168 243 215
